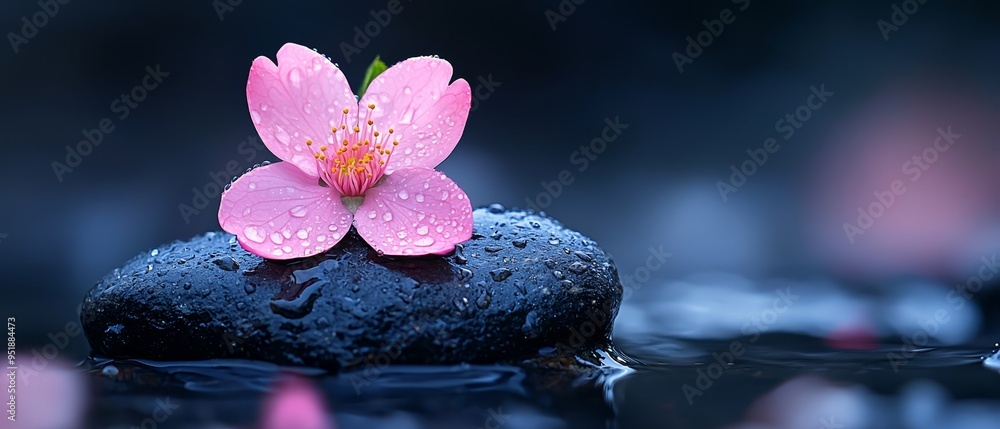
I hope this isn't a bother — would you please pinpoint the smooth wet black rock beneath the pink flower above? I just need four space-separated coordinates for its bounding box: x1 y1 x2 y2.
81 205 622 369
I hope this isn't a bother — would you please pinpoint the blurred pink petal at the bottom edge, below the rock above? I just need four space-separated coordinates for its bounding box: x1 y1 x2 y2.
261 376 334 429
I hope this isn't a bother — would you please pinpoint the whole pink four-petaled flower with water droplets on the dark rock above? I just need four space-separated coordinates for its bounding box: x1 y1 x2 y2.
219 43 472 259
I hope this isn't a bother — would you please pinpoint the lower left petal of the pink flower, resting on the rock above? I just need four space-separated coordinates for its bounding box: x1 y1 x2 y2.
219 162 352 259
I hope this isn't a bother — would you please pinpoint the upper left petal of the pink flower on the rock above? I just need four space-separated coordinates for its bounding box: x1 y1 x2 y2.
247 43 358 177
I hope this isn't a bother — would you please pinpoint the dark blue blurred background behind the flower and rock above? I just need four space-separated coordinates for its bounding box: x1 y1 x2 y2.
0 0 1000 426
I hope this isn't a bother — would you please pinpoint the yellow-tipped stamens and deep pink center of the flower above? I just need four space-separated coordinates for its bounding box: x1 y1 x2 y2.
306 104 399 197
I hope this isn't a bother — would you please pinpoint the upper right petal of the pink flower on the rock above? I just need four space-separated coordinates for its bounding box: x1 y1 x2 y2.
361 57 472 173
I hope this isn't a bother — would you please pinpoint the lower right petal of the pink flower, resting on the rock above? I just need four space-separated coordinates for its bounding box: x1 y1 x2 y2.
354 167 472 255
